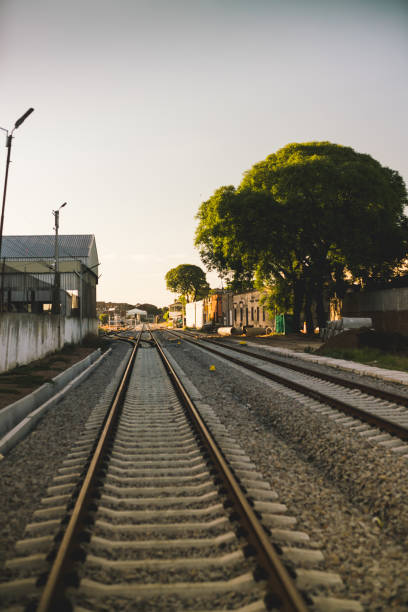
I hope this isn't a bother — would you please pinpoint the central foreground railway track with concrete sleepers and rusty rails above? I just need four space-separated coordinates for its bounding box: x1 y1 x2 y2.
0 332 361 612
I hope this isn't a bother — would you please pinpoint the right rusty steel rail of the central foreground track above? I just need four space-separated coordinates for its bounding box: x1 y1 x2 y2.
150 332 307 612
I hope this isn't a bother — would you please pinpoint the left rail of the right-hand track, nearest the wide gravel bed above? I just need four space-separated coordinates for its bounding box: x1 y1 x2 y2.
166 332 408 440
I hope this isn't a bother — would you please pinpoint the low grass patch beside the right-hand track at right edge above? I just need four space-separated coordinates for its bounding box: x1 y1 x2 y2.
318 347 408 372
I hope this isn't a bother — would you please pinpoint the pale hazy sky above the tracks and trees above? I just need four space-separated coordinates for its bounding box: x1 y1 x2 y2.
0 0 408 306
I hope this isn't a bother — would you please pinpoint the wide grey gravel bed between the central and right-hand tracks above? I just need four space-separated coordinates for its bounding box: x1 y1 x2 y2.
165 341 408 611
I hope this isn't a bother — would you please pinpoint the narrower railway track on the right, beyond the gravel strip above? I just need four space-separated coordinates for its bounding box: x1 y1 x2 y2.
165 332 408 458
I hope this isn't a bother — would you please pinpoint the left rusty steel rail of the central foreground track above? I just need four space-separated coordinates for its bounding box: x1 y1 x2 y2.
37 332 142 612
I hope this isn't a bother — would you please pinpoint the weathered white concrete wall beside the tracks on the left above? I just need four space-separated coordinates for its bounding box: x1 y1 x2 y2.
0 313 98 372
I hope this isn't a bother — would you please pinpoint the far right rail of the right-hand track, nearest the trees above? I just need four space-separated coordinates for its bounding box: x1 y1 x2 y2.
182 330 408 406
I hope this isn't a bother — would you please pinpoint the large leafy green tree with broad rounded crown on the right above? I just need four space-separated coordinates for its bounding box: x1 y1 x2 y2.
196 142 408 328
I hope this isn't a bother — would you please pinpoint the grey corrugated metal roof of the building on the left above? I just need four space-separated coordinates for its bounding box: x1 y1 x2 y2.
0 234 95 259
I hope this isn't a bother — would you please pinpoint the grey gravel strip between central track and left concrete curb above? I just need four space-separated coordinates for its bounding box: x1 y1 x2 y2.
0 342 130 570
